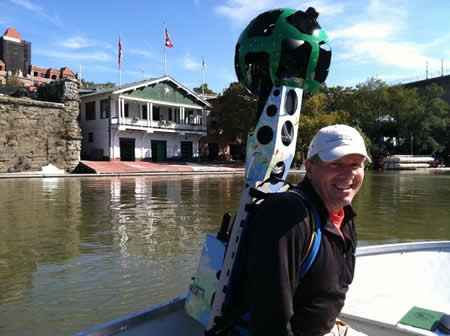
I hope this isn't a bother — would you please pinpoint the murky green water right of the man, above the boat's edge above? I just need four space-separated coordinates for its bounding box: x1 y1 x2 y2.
354 171 450 245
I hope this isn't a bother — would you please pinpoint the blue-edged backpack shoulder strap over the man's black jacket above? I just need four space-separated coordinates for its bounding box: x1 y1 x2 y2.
288 188 322 279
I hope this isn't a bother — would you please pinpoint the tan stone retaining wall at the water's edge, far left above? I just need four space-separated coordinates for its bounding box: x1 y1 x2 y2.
0 78 81 173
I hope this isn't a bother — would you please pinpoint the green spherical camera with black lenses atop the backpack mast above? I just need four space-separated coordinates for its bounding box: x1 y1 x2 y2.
234 7 331 98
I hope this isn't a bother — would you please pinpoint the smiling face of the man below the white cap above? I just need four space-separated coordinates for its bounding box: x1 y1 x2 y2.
306 154 364 213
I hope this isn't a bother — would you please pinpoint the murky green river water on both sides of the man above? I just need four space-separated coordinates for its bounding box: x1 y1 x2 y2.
0 171 450 336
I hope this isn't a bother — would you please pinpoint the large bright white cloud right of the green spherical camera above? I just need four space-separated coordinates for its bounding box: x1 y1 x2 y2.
328 0 450 75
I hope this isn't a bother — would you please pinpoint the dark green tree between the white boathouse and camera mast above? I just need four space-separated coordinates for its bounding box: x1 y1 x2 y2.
218 82 258 143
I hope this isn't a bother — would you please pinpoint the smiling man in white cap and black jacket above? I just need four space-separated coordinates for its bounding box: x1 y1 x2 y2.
247 125 370 336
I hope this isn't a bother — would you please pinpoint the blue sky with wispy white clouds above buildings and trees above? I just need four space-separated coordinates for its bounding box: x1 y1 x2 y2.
0 0 450 92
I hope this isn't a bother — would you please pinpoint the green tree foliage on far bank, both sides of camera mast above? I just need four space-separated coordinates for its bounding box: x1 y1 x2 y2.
213 78 450 166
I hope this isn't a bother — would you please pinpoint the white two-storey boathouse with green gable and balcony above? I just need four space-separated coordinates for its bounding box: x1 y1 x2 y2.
80 76 211 162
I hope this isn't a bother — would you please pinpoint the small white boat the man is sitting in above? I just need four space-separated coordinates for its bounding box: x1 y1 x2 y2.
75 241 450 336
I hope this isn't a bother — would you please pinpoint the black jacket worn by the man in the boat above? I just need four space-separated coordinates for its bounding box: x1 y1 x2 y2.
247 177 356 336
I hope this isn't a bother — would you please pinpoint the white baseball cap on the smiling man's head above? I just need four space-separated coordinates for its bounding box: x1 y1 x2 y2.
307 125 372 162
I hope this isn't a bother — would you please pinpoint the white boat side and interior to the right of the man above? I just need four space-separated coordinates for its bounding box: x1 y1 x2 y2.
341 241 450 336
